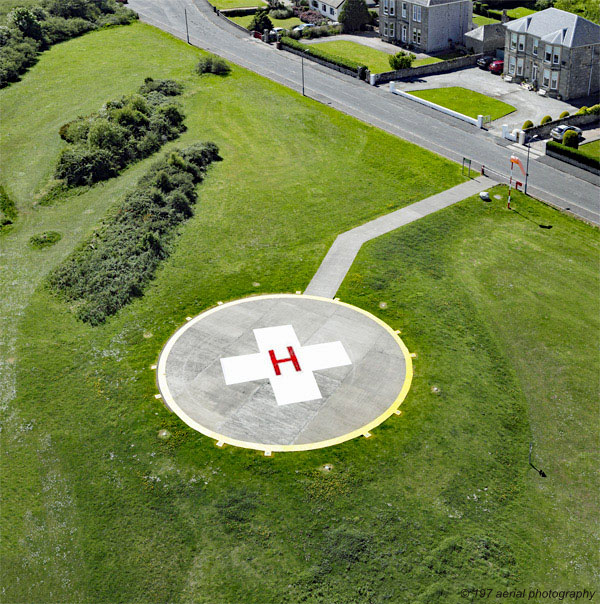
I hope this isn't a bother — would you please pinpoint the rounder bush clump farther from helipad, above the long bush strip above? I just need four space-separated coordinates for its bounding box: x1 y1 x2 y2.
54 78 185 186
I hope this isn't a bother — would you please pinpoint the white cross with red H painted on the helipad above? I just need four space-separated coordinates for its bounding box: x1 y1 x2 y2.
221 325 352 405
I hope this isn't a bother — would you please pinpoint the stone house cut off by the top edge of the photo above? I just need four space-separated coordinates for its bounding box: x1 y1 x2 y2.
379 0 473 53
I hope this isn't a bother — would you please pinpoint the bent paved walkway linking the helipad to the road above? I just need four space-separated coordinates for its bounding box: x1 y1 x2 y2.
304 176 495 298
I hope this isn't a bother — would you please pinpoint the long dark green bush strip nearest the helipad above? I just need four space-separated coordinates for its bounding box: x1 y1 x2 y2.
49 143 220 325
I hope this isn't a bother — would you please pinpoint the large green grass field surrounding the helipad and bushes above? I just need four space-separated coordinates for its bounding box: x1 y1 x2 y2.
0 18 600 604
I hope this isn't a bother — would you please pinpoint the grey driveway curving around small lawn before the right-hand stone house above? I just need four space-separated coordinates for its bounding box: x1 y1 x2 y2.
396 67 578 134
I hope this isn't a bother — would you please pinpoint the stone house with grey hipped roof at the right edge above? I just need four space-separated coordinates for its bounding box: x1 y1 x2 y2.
504 8 600 100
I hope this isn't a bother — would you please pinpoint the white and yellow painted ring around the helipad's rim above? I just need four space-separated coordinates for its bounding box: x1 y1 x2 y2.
156 294 413 454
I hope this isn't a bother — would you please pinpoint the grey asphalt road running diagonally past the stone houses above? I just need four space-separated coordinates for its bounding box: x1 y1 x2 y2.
129 0 600 224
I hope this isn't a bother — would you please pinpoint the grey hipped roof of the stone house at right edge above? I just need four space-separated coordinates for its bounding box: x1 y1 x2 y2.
505 8 600 48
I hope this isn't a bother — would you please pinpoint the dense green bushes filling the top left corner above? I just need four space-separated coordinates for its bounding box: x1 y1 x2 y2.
0 0 137 88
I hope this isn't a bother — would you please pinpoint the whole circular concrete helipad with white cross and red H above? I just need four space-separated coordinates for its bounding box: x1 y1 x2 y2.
157 294 412 452
